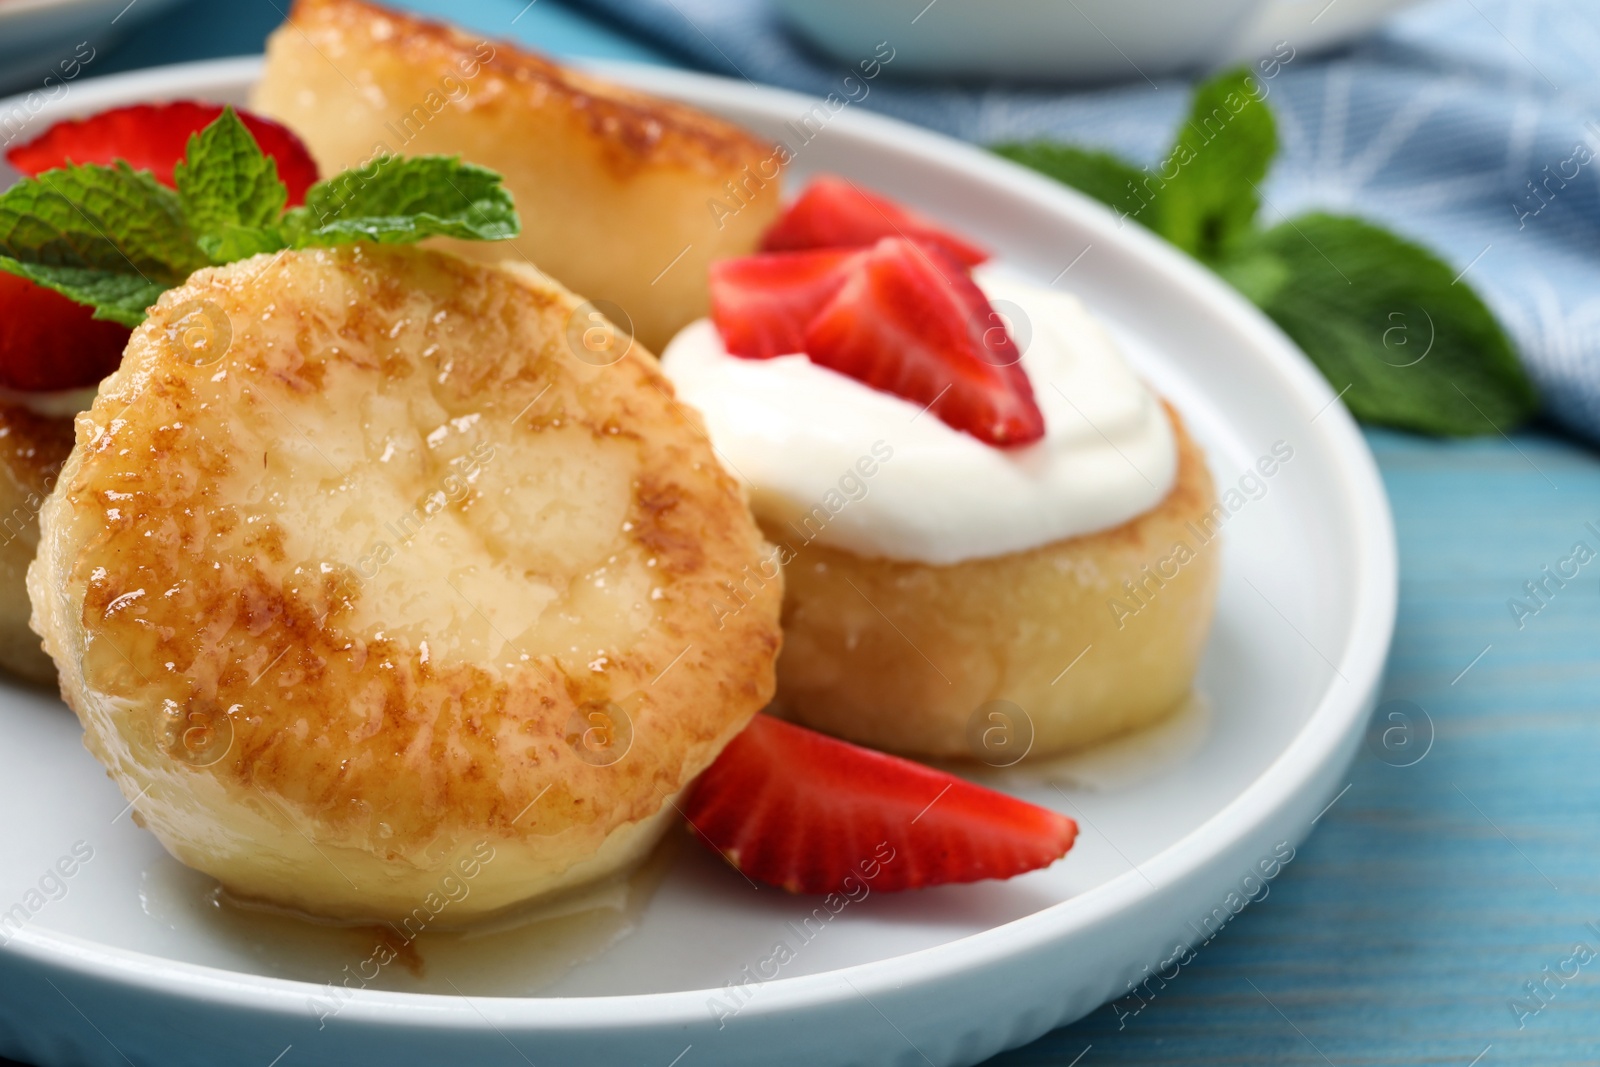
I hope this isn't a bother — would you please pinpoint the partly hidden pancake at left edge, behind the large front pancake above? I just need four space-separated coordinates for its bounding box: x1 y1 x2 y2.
0 403 72 683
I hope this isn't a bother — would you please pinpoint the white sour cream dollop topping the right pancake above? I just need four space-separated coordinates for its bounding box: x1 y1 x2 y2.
662 270 1178 565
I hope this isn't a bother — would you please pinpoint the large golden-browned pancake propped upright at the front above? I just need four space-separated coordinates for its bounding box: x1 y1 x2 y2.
29 246 779 923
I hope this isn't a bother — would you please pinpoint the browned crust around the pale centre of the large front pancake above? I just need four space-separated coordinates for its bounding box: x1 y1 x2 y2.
35 248 779 854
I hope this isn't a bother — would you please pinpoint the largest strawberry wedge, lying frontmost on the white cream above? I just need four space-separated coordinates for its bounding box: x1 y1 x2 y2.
805 237 1045 446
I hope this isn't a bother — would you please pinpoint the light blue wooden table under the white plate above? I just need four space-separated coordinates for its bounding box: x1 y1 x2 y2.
25 0 1600 1067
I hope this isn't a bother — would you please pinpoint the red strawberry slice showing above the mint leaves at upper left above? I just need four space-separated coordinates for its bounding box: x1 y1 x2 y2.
6 101 317 206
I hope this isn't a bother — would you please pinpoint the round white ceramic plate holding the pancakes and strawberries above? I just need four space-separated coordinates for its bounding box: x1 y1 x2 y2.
0 59 1395 1067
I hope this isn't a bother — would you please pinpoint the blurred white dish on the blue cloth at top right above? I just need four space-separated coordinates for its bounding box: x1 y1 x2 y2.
773 0 1416 82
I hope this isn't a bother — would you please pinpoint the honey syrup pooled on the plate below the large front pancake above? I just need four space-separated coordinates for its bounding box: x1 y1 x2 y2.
139 833 685 998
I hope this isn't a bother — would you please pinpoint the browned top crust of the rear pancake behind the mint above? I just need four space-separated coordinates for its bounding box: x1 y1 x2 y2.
290 0 773 176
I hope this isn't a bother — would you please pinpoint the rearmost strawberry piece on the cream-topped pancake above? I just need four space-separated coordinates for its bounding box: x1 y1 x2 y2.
762 174 989 267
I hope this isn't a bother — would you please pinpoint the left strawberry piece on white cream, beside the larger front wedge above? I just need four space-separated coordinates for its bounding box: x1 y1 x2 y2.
710 248 861 360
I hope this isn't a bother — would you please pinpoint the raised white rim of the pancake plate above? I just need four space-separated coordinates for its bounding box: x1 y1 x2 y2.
0 54 1398 1032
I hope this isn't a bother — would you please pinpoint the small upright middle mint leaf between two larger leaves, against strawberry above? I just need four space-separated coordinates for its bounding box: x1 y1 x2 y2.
173 107 288 246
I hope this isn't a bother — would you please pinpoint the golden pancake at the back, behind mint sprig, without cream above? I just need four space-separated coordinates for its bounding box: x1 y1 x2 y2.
251 0 782 350
